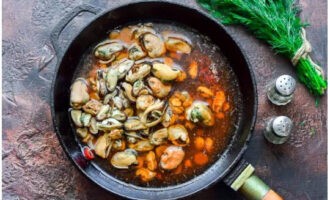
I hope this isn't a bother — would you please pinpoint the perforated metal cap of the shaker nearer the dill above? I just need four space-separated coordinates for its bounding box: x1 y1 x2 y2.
275 75 296 96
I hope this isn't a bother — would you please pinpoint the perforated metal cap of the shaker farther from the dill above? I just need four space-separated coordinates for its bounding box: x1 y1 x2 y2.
273 116 292 137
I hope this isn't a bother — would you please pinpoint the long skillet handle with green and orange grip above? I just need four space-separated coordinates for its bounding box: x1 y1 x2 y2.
224 160 283 200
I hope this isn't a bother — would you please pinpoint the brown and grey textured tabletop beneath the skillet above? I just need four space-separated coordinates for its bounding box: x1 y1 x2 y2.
2 0 327 200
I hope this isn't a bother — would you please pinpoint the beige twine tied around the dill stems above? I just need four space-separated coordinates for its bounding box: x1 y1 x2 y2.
291 28 324 77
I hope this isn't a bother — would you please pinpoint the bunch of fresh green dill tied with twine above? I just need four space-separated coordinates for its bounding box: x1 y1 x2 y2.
197 0 327 96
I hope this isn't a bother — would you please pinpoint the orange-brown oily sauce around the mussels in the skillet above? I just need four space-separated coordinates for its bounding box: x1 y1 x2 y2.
78 24 238 186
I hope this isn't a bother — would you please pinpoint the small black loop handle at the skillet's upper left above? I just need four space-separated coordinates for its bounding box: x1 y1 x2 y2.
50 4 101 55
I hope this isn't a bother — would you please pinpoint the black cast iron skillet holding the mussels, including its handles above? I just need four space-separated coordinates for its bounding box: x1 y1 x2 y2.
51 1 282 199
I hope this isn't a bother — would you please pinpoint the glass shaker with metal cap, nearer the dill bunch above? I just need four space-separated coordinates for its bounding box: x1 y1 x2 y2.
267 75 296 106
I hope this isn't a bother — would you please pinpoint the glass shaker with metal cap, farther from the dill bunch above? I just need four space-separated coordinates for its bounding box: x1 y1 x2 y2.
264 116 293 144
